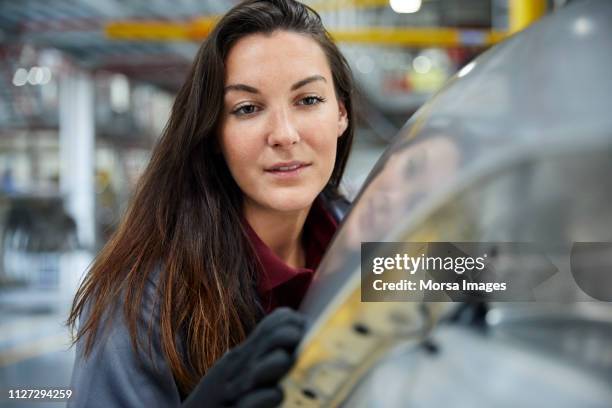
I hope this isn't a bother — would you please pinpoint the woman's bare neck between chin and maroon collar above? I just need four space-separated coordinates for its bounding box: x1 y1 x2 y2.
244 204 310 268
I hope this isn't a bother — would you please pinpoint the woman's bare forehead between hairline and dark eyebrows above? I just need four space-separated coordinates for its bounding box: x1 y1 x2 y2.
225 31 331 86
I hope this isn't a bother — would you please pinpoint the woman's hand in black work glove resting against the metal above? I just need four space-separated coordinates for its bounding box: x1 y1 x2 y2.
182 308 305 408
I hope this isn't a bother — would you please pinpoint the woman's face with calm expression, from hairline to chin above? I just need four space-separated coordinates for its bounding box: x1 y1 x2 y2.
220 31 348 211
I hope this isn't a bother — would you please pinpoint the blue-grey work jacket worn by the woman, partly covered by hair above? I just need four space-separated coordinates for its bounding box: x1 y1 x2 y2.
68 195 350 408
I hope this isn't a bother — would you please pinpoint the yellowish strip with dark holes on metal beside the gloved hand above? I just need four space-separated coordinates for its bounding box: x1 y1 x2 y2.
283 279 442 407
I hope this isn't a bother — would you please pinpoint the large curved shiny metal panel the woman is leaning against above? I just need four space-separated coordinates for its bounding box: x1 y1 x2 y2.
284 0 612 407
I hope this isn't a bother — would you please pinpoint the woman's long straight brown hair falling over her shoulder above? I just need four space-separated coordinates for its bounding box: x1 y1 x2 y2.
68 0 354 393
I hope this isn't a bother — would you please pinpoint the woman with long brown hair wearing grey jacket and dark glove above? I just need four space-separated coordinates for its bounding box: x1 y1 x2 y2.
68 0 353 407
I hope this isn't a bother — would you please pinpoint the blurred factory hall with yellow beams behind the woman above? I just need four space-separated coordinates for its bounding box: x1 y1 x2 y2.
0 0 568 407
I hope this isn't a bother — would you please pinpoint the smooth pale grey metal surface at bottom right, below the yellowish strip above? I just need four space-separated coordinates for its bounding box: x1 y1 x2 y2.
344 325 612 408
